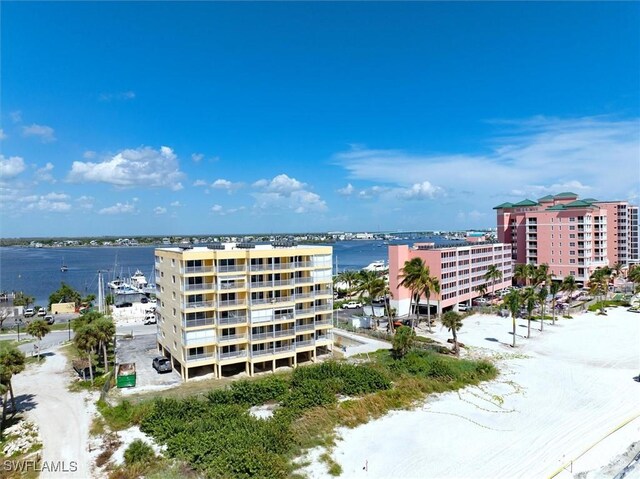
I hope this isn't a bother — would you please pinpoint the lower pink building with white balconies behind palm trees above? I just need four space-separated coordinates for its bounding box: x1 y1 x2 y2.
389 238 512 316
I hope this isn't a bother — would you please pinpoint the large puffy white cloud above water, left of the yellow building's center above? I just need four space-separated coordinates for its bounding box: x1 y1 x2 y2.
69 146 184 191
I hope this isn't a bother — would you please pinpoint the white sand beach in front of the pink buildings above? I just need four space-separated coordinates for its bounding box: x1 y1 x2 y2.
302 308 640 478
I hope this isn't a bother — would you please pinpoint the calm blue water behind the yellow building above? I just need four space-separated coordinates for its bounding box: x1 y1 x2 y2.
0 239 438 304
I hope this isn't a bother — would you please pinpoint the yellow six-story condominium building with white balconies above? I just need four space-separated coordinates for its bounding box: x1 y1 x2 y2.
155 242 333 380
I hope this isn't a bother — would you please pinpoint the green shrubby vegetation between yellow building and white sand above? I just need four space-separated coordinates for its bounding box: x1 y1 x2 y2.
98 350 497 479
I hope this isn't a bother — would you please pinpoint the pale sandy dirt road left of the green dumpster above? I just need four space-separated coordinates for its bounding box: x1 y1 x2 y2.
13 348 92 479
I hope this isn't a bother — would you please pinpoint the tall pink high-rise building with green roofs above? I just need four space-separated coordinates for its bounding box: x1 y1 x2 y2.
494 193 637 282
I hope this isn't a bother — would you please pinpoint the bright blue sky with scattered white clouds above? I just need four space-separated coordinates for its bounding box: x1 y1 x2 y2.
0 2 640 237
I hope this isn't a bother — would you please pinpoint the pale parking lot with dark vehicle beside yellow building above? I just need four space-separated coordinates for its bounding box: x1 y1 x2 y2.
116 329 182 394
